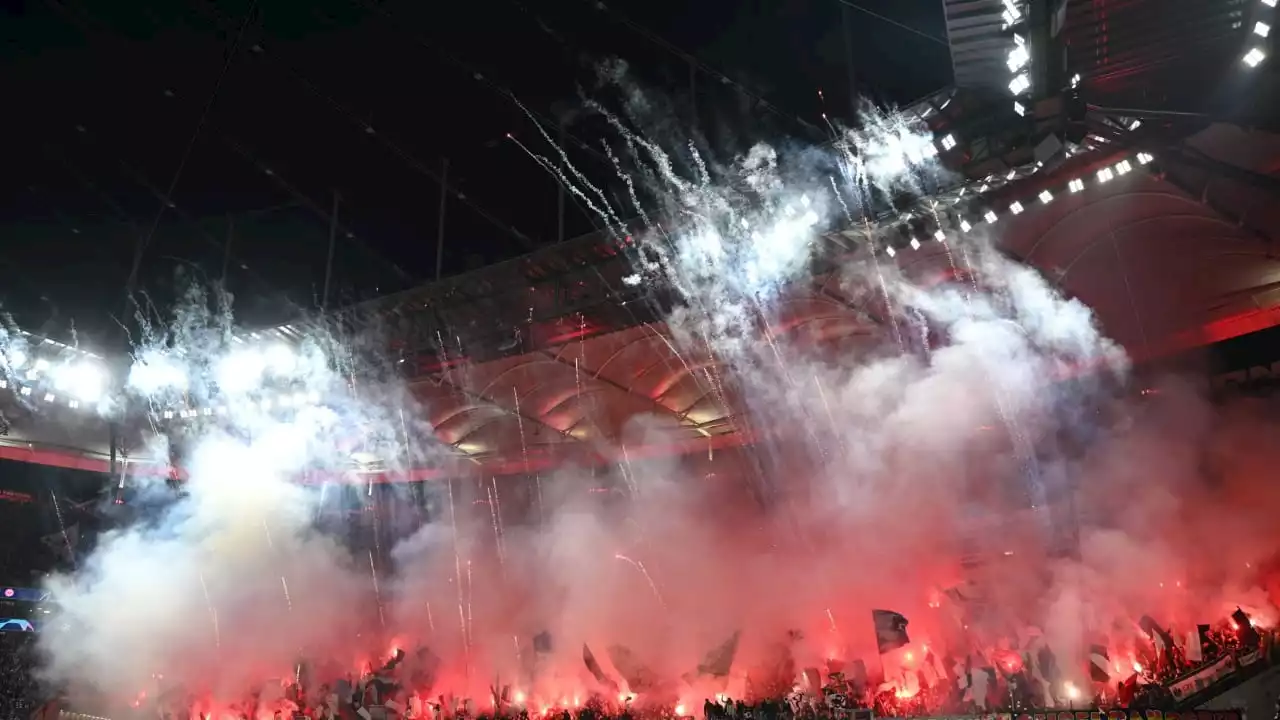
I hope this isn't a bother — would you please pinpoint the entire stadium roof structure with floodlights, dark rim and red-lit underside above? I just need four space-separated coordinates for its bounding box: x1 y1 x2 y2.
0 0 1280 478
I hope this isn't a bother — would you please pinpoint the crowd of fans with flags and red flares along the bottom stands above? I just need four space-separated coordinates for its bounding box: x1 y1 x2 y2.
0 607 1274 720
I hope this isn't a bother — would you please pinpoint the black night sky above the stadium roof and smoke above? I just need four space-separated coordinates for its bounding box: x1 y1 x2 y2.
0 0 951 347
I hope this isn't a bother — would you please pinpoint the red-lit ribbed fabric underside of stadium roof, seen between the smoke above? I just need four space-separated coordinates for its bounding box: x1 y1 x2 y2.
5 120 1280 479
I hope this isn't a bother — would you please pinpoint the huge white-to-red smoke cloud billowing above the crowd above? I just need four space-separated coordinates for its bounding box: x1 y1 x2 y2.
27 68 1280 706
